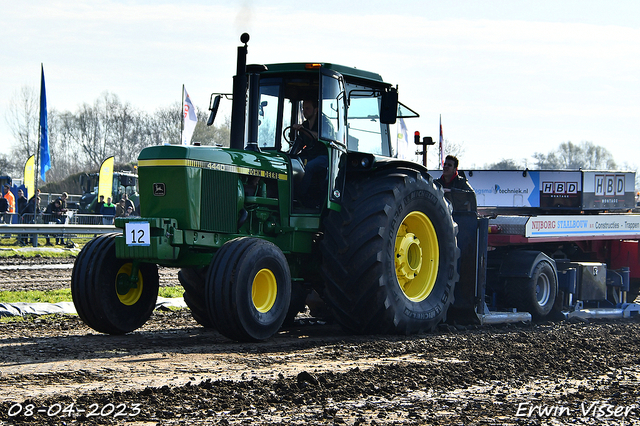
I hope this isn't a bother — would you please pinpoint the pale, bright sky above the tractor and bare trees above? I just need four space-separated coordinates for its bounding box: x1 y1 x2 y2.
0 0 640 168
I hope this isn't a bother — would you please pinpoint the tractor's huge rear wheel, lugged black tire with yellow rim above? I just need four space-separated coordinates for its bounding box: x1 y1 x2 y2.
321 169 460 334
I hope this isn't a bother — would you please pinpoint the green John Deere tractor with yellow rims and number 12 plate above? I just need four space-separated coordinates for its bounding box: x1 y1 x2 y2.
71 34 459 341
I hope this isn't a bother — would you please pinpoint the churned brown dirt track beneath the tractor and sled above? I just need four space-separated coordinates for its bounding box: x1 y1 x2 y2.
0 255 640 425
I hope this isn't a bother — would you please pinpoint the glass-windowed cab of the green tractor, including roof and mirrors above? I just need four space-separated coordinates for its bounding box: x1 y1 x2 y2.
209 63 417 213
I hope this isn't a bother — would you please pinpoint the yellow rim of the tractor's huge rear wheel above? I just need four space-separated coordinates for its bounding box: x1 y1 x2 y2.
395 211 440 302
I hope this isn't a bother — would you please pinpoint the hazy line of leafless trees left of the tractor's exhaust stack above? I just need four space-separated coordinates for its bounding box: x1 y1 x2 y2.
0 87 230 186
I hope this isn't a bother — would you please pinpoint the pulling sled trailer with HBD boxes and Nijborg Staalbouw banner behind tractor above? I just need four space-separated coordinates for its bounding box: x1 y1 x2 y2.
452 170 640 323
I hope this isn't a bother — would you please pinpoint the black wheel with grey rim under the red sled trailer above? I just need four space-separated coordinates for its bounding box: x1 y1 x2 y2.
505 260 558 320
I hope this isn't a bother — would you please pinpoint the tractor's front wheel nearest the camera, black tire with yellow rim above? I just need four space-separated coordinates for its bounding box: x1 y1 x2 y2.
206 237 291 342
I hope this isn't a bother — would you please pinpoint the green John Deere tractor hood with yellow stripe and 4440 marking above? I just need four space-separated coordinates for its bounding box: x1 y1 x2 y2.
138 145 289 233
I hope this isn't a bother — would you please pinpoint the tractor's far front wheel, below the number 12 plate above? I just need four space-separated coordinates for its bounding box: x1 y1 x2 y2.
71 234 160 334
